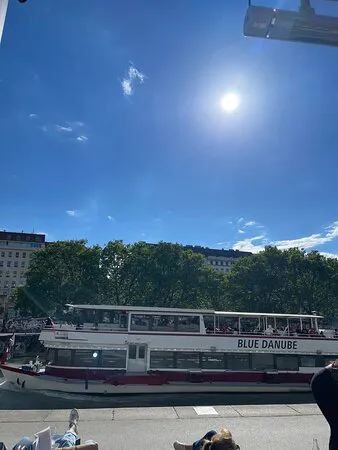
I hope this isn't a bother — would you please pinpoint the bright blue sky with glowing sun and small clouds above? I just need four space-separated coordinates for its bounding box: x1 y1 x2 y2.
0 0 338 255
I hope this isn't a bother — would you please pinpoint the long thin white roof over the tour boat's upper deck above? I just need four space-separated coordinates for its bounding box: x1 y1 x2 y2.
66 304 324 319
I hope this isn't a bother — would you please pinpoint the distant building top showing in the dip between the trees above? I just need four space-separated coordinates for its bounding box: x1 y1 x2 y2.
185 245 252 272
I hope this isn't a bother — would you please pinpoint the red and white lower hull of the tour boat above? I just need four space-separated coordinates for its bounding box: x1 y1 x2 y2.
1 365 310 395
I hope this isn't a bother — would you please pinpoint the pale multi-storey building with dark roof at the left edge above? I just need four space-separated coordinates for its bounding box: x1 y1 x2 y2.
0 231 46 307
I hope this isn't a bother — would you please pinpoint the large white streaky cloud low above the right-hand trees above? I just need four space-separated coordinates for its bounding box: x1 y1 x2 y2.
233 221 338 254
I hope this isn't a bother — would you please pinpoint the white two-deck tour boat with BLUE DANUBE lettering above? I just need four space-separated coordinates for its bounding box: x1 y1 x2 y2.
0 305 338 395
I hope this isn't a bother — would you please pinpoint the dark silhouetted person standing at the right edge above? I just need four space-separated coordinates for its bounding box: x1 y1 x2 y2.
311 359 338 450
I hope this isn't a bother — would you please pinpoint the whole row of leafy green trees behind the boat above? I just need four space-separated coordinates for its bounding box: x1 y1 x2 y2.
15 240 338 317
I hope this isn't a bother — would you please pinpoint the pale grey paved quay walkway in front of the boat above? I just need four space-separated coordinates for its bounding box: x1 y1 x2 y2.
0 404 328 450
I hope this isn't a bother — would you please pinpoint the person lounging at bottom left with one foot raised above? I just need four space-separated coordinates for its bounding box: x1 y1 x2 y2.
13 408 82 450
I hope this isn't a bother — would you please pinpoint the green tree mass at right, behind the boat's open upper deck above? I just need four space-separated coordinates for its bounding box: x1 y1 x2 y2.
227 247 338 317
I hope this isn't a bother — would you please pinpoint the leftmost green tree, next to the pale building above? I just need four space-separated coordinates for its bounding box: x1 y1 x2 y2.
16 240 101 315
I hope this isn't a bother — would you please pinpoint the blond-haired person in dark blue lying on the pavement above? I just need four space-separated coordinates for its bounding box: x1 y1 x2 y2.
173 429 240 450
